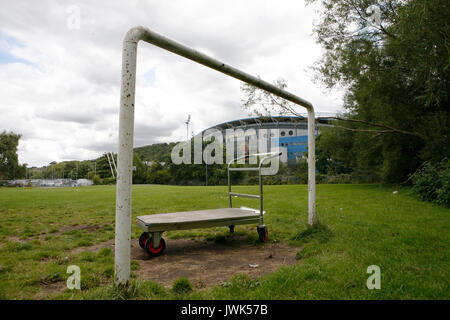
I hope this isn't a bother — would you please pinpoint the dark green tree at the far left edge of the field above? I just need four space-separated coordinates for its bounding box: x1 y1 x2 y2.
0 131 26 180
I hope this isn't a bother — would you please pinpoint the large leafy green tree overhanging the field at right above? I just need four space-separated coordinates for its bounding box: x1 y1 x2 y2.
243 0 450 182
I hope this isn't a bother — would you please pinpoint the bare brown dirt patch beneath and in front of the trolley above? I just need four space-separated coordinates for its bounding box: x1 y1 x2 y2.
131 236 300 288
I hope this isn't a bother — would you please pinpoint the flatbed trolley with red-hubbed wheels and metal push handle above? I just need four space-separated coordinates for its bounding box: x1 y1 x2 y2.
137 152 281 257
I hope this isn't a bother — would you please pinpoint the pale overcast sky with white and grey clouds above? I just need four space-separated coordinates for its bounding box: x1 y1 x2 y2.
0 0 342 167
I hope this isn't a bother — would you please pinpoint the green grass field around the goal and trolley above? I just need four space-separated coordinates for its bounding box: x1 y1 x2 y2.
0 185 450 299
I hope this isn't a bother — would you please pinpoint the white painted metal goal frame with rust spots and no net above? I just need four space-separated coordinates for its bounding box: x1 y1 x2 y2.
114 26 316 285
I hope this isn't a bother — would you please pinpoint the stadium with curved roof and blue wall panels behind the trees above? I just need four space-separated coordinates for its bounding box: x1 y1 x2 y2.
201 114 335 163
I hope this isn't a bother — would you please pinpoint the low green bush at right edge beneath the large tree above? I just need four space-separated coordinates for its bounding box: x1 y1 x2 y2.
412 158 450 207
